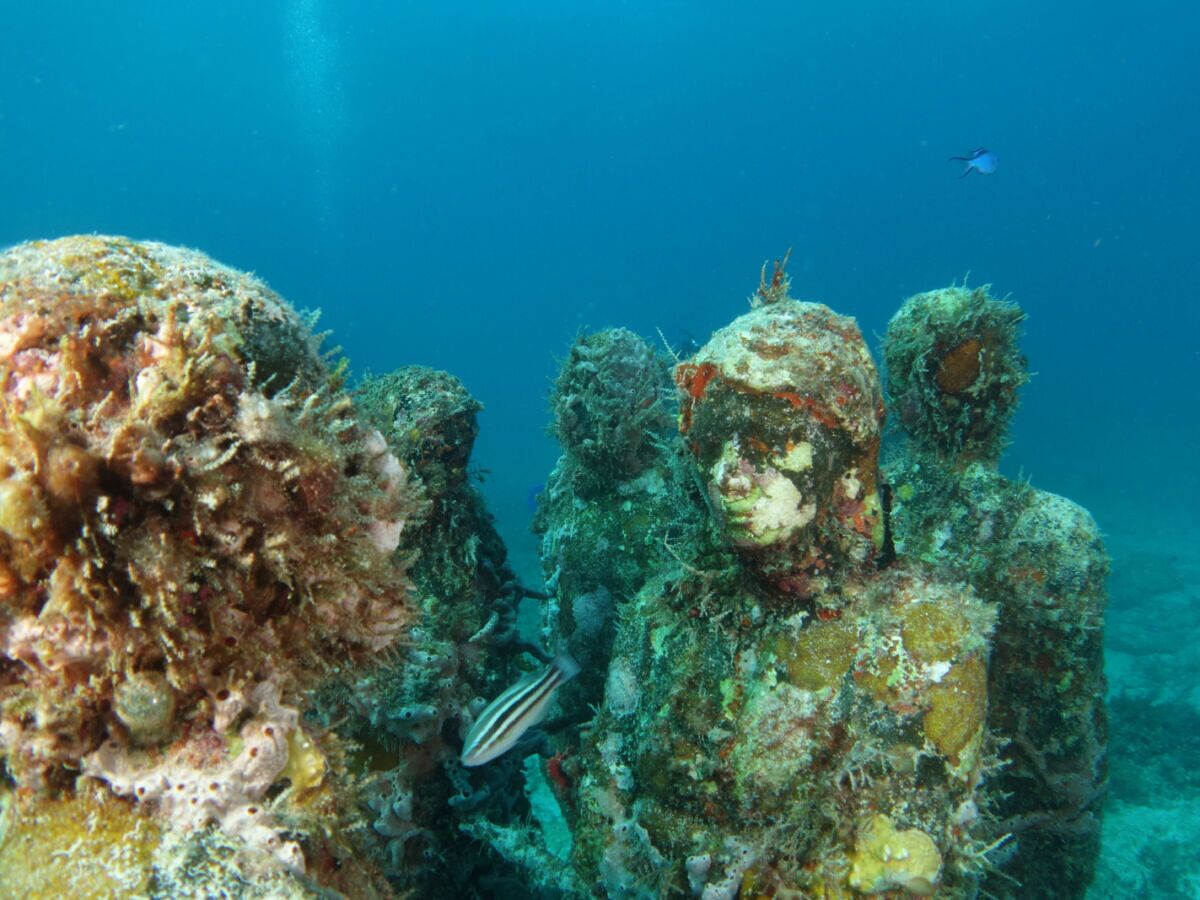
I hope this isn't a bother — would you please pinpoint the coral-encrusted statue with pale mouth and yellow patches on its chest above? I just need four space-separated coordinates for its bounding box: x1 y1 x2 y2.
534 270 996 900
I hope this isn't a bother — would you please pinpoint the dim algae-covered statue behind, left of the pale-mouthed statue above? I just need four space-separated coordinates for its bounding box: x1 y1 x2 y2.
534 329 702 709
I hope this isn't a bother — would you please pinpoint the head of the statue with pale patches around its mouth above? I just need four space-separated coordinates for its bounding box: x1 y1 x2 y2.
676 300 884 607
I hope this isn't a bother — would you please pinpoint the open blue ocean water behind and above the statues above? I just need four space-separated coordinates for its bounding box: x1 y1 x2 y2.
0 0 1200 896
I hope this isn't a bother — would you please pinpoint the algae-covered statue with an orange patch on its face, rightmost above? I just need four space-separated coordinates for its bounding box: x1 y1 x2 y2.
884 287 1108 898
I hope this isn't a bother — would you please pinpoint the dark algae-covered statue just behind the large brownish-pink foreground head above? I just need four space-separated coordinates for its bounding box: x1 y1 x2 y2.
313 366 548 896
